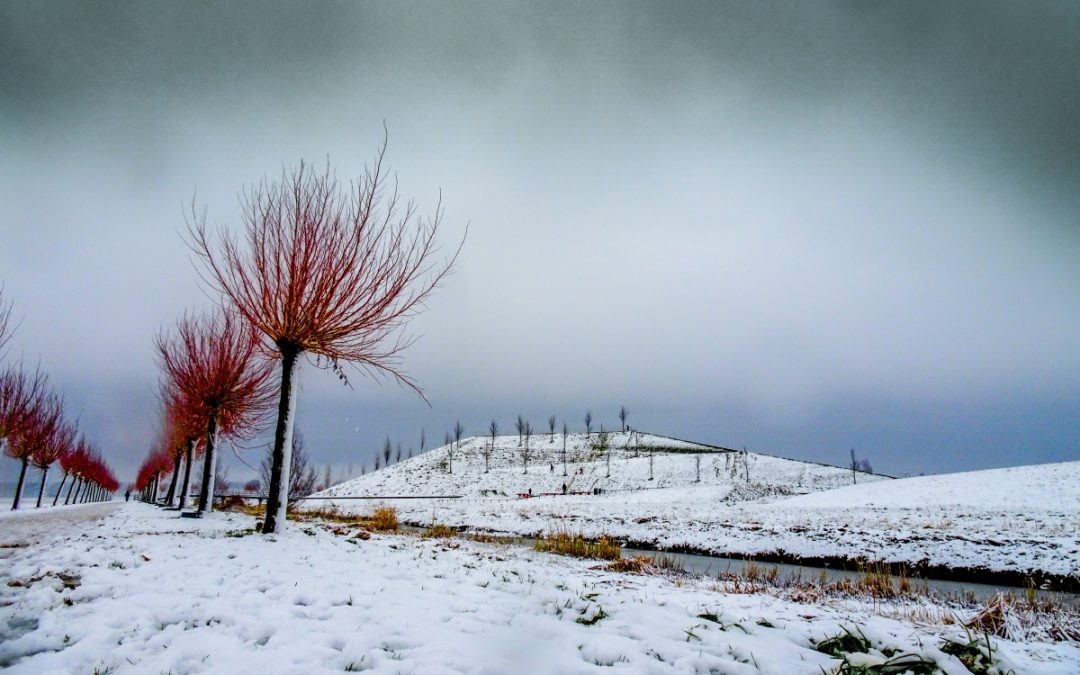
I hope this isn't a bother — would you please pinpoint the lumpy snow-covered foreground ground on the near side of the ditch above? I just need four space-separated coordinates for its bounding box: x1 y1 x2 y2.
0 502 1080 675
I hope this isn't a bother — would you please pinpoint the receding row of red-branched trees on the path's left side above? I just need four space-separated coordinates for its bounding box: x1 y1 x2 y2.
0 288 120 510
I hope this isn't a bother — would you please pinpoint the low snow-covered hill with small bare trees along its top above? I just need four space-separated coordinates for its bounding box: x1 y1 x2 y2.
320 432 883 500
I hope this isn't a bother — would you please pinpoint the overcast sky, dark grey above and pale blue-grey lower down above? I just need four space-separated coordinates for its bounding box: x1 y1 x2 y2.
0 1 1080 480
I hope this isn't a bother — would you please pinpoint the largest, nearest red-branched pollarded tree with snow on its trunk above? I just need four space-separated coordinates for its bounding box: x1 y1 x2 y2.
188 140 464 534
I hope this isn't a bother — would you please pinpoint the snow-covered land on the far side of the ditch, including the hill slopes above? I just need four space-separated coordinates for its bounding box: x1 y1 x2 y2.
311 434 1080 577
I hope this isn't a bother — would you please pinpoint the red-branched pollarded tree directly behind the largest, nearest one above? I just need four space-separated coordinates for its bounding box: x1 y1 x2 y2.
154 312 275 512
